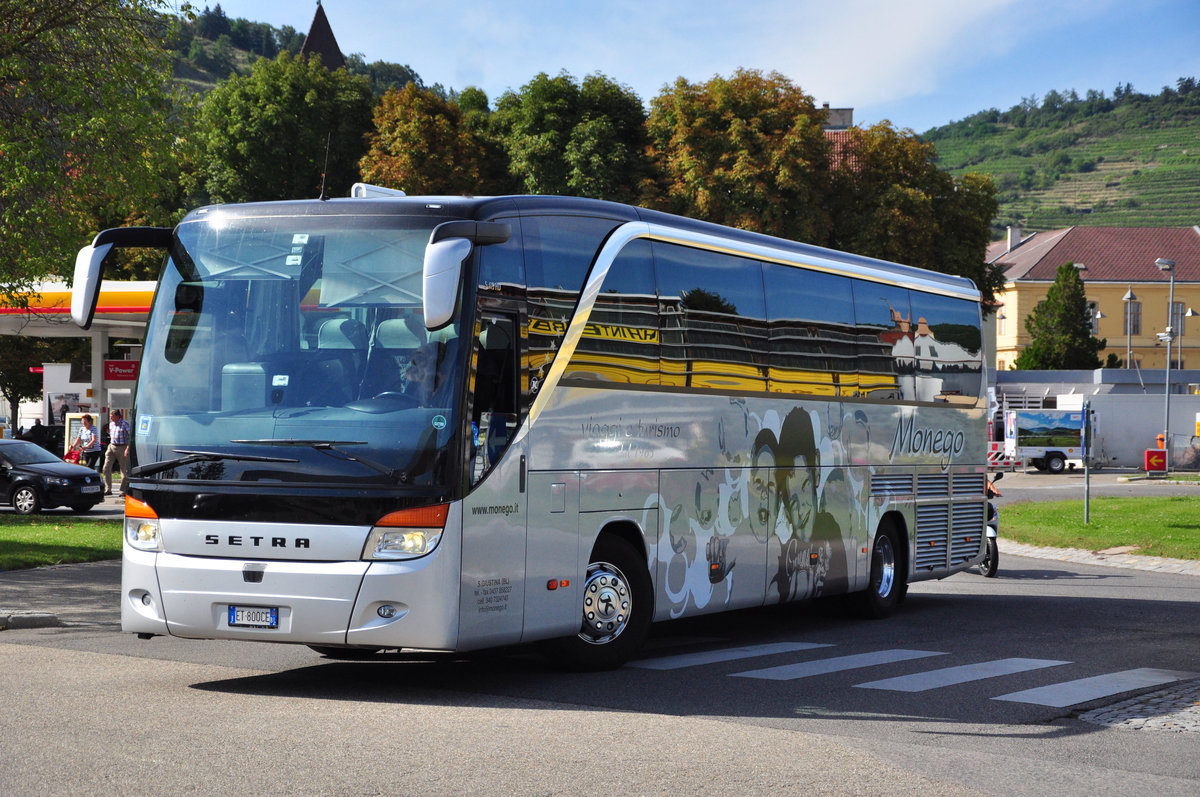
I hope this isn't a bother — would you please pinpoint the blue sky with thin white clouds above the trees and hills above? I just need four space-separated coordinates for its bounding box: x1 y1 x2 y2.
193 0 1200 132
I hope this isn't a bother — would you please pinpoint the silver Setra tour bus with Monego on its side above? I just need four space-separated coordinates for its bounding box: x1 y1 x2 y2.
72 185 986 669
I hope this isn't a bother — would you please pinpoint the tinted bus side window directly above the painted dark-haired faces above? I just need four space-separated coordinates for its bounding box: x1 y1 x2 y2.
763 264 858 396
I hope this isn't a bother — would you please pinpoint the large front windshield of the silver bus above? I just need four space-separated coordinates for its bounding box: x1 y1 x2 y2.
133 209 462 489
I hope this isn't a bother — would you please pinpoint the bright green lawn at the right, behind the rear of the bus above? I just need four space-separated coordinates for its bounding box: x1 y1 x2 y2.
1000 496 1200 559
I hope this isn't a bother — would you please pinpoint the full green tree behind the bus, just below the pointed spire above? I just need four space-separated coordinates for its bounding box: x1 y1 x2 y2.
199 53 372 202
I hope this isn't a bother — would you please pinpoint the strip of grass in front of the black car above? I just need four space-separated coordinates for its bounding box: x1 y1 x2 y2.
0 513 122 570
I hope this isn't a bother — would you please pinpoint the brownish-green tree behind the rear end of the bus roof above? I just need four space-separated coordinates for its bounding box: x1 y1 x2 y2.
829 121 1003 304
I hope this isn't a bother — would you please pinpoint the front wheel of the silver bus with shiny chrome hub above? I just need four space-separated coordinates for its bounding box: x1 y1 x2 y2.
552 535 654 670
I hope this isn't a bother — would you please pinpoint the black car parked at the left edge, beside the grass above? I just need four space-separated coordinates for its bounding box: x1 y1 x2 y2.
0 439 104 515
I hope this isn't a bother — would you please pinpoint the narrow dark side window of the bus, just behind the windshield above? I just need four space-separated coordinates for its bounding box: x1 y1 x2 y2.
472 314 520 484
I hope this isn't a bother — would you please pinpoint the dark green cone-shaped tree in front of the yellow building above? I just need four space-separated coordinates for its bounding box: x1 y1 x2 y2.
1013 263 1108 371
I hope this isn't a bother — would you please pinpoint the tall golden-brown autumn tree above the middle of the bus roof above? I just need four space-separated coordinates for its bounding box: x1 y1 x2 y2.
643 70 830 244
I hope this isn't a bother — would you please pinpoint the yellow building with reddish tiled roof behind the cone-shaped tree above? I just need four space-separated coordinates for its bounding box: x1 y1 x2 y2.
988 227 1200 371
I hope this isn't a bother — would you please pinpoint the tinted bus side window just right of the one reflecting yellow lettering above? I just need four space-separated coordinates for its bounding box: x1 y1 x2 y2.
654 242 767 390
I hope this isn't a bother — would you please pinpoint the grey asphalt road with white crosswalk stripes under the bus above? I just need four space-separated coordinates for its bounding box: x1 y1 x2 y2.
0 547 1200 796
